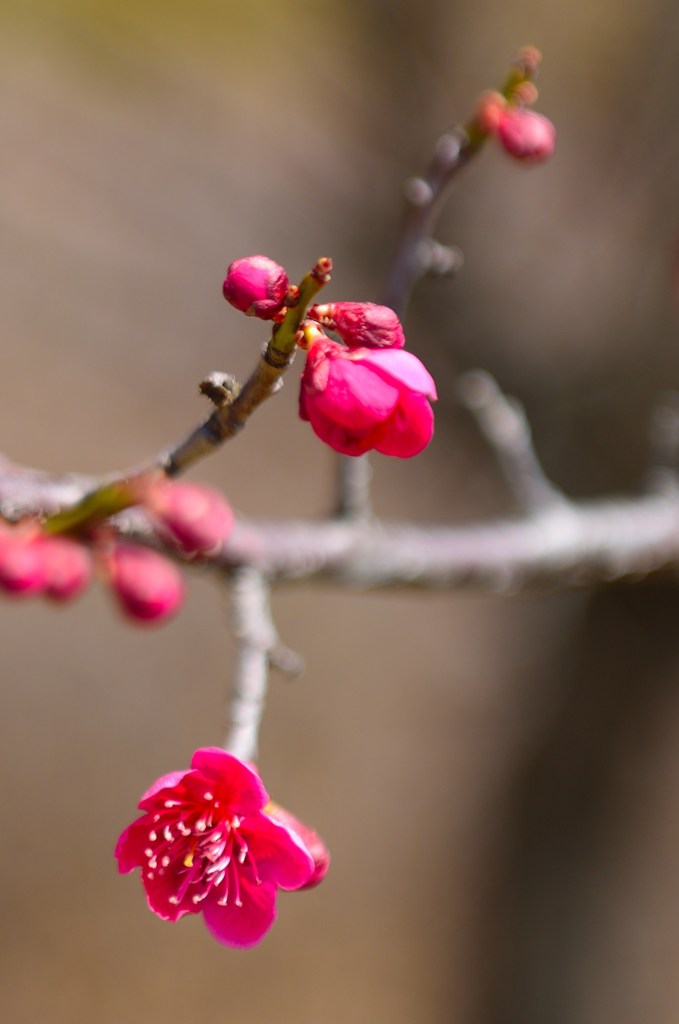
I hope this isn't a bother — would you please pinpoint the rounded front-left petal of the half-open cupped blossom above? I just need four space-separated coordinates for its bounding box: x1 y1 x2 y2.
306 355 398 431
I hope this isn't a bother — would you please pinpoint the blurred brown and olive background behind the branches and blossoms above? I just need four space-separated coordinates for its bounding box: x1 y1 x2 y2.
0 0 679 1024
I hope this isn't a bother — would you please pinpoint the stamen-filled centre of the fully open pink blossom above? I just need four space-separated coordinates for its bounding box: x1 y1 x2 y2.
144 793 261 909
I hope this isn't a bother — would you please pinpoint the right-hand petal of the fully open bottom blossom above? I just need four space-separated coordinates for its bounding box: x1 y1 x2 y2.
243 814 313 889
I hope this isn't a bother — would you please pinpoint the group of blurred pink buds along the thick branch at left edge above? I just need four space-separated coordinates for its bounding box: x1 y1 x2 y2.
0 478 234 625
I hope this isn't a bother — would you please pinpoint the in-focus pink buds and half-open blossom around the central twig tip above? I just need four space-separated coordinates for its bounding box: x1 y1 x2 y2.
223 256 436 459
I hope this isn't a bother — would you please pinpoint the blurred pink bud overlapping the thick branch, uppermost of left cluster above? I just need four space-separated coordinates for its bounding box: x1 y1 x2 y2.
144 481 234 554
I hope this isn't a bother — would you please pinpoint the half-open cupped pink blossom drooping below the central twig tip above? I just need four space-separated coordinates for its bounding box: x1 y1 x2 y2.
299 332 436 459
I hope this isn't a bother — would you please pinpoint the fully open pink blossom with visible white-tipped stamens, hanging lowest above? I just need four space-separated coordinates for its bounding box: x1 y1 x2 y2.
116 748 315 948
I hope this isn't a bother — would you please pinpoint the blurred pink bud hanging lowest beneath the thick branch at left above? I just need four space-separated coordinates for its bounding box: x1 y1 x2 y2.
105 544 184 624
